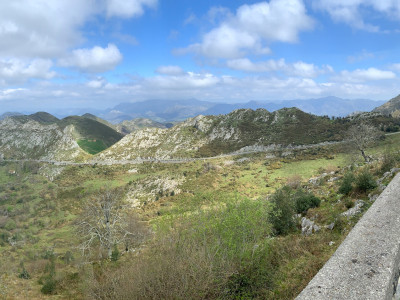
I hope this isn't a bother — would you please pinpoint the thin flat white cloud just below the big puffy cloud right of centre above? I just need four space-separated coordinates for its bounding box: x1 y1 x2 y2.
227 58 333 77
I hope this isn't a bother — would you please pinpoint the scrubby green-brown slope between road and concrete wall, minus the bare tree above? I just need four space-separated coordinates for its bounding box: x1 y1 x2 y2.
0 134 400 299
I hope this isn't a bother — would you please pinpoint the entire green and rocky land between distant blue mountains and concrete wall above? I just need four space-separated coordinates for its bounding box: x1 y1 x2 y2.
0 95 400 299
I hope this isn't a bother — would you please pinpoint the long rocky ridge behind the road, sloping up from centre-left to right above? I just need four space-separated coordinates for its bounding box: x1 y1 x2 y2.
93 108 400 161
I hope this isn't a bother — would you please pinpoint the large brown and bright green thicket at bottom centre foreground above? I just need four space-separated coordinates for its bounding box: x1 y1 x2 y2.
85 199 273 300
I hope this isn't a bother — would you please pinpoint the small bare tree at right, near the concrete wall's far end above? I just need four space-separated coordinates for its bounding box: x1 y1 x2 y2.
346 123 383 162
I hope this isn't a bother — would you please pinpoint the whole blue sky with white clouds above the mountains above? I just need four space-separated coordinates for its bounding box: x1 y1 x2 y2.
0 0 400 112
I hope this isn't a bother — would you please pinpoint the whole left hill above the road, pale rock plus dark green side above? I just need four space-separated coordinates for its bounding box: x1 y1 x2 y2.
0 112 123 160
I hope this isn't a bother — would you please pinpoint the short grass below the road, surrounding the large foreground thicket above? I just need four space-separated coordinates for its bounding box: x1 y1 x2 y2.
0 134 400 299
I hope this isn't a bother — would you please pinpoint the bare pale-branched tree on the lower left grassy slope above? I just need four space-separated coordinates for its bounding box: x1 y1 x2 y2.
76 187 148 258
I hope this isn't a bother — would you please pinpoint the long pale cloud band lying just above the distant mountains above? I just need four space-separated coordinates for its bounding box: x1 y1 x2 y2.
0 72 400 113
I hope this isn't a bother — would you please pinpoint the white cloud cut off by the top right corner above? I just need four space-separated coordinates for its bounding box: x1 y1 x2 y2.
313 0 400 32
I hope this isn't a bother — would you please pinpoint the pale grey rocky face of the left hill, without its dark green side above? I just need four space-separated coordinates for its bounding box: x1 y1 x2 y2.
0 118 85 160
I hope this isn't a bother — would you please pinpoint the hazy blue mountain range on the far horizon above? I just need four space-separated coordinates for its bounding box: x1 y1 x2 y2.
0 97 385 123
